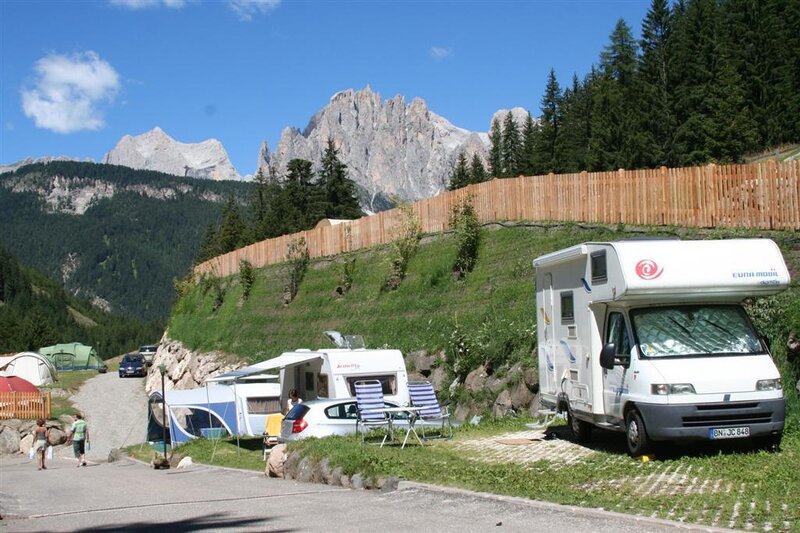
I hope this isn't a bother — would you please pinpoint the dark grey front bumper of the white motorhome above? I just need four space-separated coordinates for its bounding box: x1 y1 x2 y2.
636 399 786 440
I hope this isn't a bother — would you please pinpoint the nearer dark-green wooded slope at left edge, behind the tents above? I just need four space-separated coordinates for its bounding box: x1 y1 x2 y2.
0 246 163 359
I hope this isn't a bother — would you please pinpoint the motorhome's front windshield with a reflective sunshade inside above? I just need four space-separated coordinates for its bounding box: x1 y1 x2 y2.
631 305 764 358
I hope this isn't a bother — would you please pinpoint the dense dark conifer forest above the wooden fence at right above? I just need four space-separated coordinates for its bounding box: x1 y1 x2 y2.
450 0 800 188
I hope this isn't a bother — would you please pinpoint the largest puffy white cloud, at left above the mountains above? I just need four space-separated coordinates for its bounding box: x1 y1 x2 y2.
21 51 120 133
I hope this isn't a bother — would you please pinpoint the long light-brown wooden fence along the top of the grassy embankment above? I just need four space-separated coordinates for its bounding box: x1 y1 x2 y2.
194 161 800 276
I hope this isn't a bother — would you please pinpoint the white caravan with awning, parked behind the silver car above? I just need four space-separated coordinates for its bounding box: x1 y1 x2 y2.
208 332 409 412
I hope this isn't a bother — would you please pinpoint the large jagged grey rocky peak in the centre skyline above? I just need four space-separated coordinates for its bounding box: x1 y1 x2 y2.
259 86 488 208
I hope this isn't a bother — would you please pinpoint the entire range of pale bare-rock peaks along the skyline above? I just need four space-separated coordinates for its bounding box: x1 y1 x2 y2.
6 86 527 208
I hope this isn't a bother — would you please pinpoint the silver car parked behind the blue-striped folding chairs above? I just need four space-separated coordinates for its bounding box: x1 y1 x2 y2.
279 398 441 442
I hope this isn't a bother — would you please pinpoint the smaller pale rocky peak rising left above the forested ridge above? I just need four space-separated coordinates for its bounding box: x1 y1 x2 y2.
103 126 241 180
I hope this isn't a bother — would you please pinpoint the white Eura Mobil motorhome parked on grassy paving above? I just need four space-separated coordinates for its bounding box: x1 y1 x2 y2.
533 239 789 455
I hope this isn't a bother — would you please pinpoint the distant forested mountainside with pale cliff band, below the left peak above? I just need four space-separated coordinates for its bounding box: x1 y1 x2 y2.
0 162 252 320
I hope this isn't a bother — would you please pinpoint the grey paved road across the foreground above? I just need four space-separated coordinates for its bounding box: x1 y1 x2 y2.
0 457 724 533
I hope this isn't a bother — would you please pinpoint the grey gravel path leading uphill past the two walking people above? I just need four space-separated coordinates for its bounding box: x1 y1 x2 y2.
62 372 147 462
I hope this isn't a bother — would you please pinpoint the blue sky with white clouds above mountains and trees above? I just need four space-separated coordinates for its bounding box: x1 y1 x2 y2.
0 0 649 174
